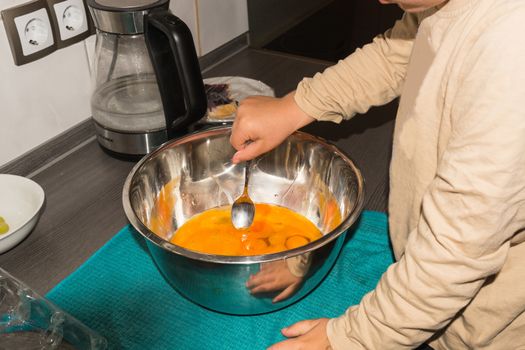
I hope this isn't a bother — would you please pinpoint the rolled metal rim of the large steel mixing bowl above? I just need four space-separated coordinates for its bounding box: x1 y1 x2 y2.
122 126 365 264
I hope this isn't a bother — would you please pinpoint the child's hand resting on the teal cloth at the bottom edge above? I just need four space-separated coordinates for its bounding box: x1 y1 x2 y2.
268 318 332 350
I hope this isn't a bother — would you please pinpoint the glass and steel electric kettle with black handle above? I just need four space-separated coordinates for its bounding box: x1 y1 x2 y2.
87 0 207 156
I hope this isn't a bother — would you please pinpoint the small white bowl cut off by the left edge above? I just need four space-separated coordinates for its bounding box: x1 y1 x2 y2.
0 174 45 253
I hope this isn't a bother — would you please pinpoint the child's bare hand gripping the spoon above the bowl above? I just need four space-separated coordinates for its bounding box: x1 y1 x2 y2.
230 93 314 163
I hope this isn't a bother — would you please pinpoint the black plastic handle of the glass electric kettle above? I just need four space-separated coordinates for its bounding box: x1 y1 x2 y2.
144 9 207 139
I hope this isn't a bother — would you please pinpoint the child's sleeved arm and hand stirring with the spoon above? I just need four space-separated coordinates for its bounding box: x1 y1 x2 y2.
230 14 425 163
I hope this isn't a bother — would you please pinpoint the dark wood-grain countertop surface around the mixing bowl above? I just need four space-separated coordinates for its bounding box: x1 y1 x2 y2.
0 49 396 294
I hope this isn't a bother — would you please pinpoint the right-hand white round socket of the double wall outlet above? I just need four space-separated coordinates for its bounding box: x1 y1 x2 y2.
53 0 89 41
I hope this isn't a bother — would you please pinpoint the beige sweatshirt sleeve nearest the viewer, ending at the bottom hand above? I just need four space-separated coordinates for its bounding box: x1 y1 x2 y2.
327 6 525 349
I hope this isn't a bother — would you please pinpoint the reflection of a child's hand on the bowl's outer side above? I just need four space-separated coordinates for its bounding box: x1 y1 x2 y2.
246 260 303 303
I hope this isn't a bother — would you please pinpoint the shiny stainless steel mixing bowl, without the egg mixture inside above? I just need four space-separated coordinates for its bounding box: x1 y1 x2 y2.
123 127 364 315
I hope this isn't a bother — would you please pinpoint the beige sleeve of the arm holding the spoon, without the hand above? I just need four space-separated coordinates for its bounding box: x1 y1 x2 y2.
295 14 425 122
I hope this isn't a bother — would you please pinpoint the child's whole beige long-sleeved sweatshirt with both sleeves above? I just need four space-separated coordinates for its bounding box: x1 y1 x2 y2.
295 0 525 350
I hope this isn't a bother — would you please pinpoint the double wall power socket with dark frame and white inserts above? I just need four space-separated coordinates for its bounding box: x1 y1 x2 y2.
2 0 94 66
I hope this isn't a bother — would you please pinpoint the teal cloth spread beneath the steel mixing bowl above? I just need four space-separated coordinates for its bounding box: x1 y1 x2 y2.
47 211 393 350
